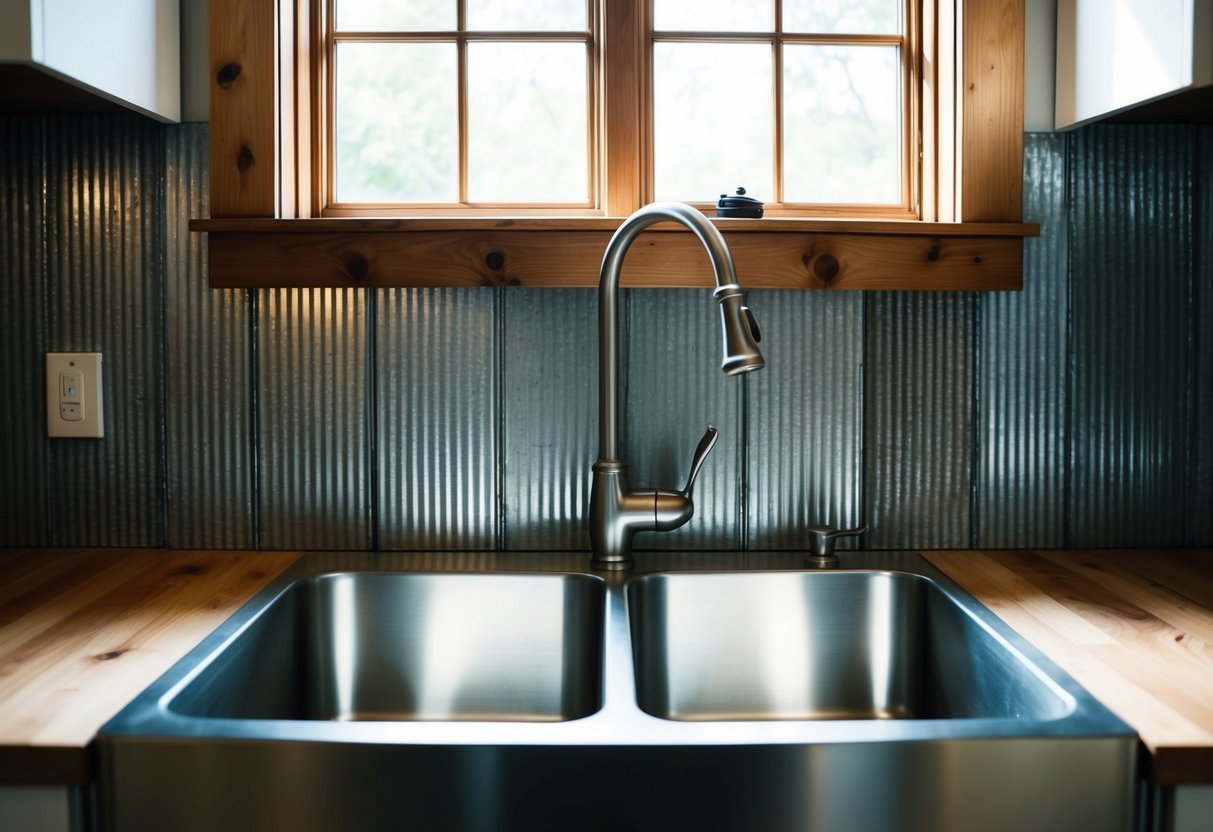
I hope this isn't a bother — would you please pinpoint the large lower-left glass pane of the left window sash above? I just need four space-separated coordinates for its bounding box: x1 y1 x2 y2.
334 44 459 203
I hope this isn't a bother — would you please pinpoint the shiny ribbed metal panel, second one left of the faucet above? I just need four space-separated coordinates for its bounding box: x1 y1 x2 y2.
375 289 499 549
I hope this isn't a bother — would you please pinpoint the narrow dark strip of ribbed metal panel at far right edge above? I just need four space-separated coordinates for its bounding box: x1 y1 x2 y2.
1188 125 1213 546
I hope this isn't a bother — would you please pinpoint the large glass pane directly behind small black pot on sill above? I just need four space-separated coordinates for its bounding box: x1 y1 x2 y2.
653 42 775 203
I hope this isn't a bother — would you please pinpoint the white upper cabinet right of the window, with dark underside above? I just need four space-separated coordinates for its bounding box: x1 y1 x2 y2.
1057 0 1213 130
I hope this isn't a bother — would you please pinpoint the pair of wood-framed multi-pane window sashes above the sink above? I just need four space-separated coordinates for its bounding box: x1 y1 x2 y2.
319 0 922 218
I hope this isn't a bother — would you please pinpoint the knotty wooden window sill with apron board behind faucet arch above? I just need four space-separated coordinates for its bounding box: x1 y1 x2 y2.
190 217 1040 291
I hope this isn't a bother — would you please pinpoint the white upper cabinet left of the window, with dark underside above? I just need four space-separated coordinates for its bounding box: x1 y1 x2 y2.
0 0 181 121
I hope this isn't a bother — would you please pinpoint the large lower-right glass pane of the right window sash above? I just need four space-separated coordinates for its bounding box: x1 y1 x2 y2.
784 45 901 205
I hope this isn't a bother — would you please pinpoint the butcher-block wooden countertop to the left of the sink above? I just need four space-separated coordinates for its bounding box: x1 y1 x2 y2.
0 549 298 785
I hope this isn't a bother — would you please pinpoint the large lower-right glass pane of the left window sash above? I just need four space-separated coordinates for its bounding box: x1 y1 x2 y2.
467 42 590 203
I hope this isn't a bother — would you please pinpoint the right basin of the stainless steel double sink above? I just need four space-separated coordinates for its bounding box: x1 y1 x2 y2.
627 570 1075 722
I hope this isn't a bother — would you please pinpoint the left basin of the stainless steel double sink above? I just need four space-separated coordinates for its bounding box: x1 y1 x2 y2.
171 572 605 722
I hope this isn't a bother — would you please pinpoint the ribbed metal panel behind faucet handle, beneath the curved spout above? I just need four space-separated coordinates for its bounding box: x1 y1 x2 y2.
621 289 748 549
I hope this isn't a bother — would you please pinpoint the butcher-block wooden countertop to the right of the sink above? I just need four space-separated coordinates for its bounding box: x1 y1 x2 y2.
923 549 1213 786
